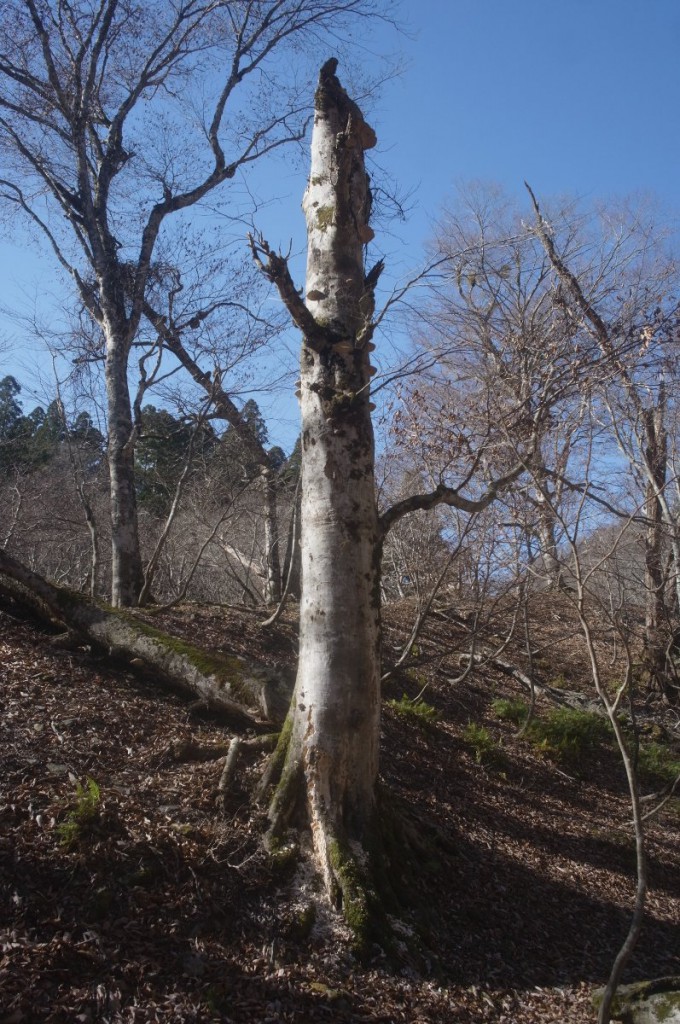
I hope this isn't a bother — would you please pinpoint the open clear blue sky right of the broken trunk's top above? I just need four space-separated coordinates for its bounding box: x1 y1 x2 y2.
379 0 680 225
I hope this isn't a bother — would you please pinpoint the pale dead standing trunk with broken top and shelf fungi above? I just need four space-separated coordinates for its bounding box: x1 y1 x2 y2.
253 60 382 928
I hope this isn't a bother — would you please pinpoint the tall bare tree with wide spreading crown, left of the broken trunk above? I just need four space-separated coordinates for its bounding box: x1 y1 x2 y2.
0 0 393 605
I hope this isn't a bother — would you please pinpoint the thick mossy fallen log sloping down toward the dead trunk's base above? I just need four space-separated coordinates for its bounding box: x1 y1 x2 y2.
0 551 293 729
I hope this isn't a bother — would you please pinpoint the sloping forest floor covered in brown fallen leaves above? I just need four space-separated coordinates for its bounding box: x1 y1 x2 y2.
0 599 680 1024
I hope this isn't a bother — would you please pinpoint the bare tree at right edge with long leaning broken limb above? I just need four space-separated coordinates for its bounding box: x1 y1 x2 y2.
527 186 680 701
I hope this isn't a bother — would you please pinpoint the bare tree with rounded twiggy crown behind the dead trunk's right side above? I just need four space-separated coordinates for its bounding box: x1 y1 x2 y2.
411 184 593 587
